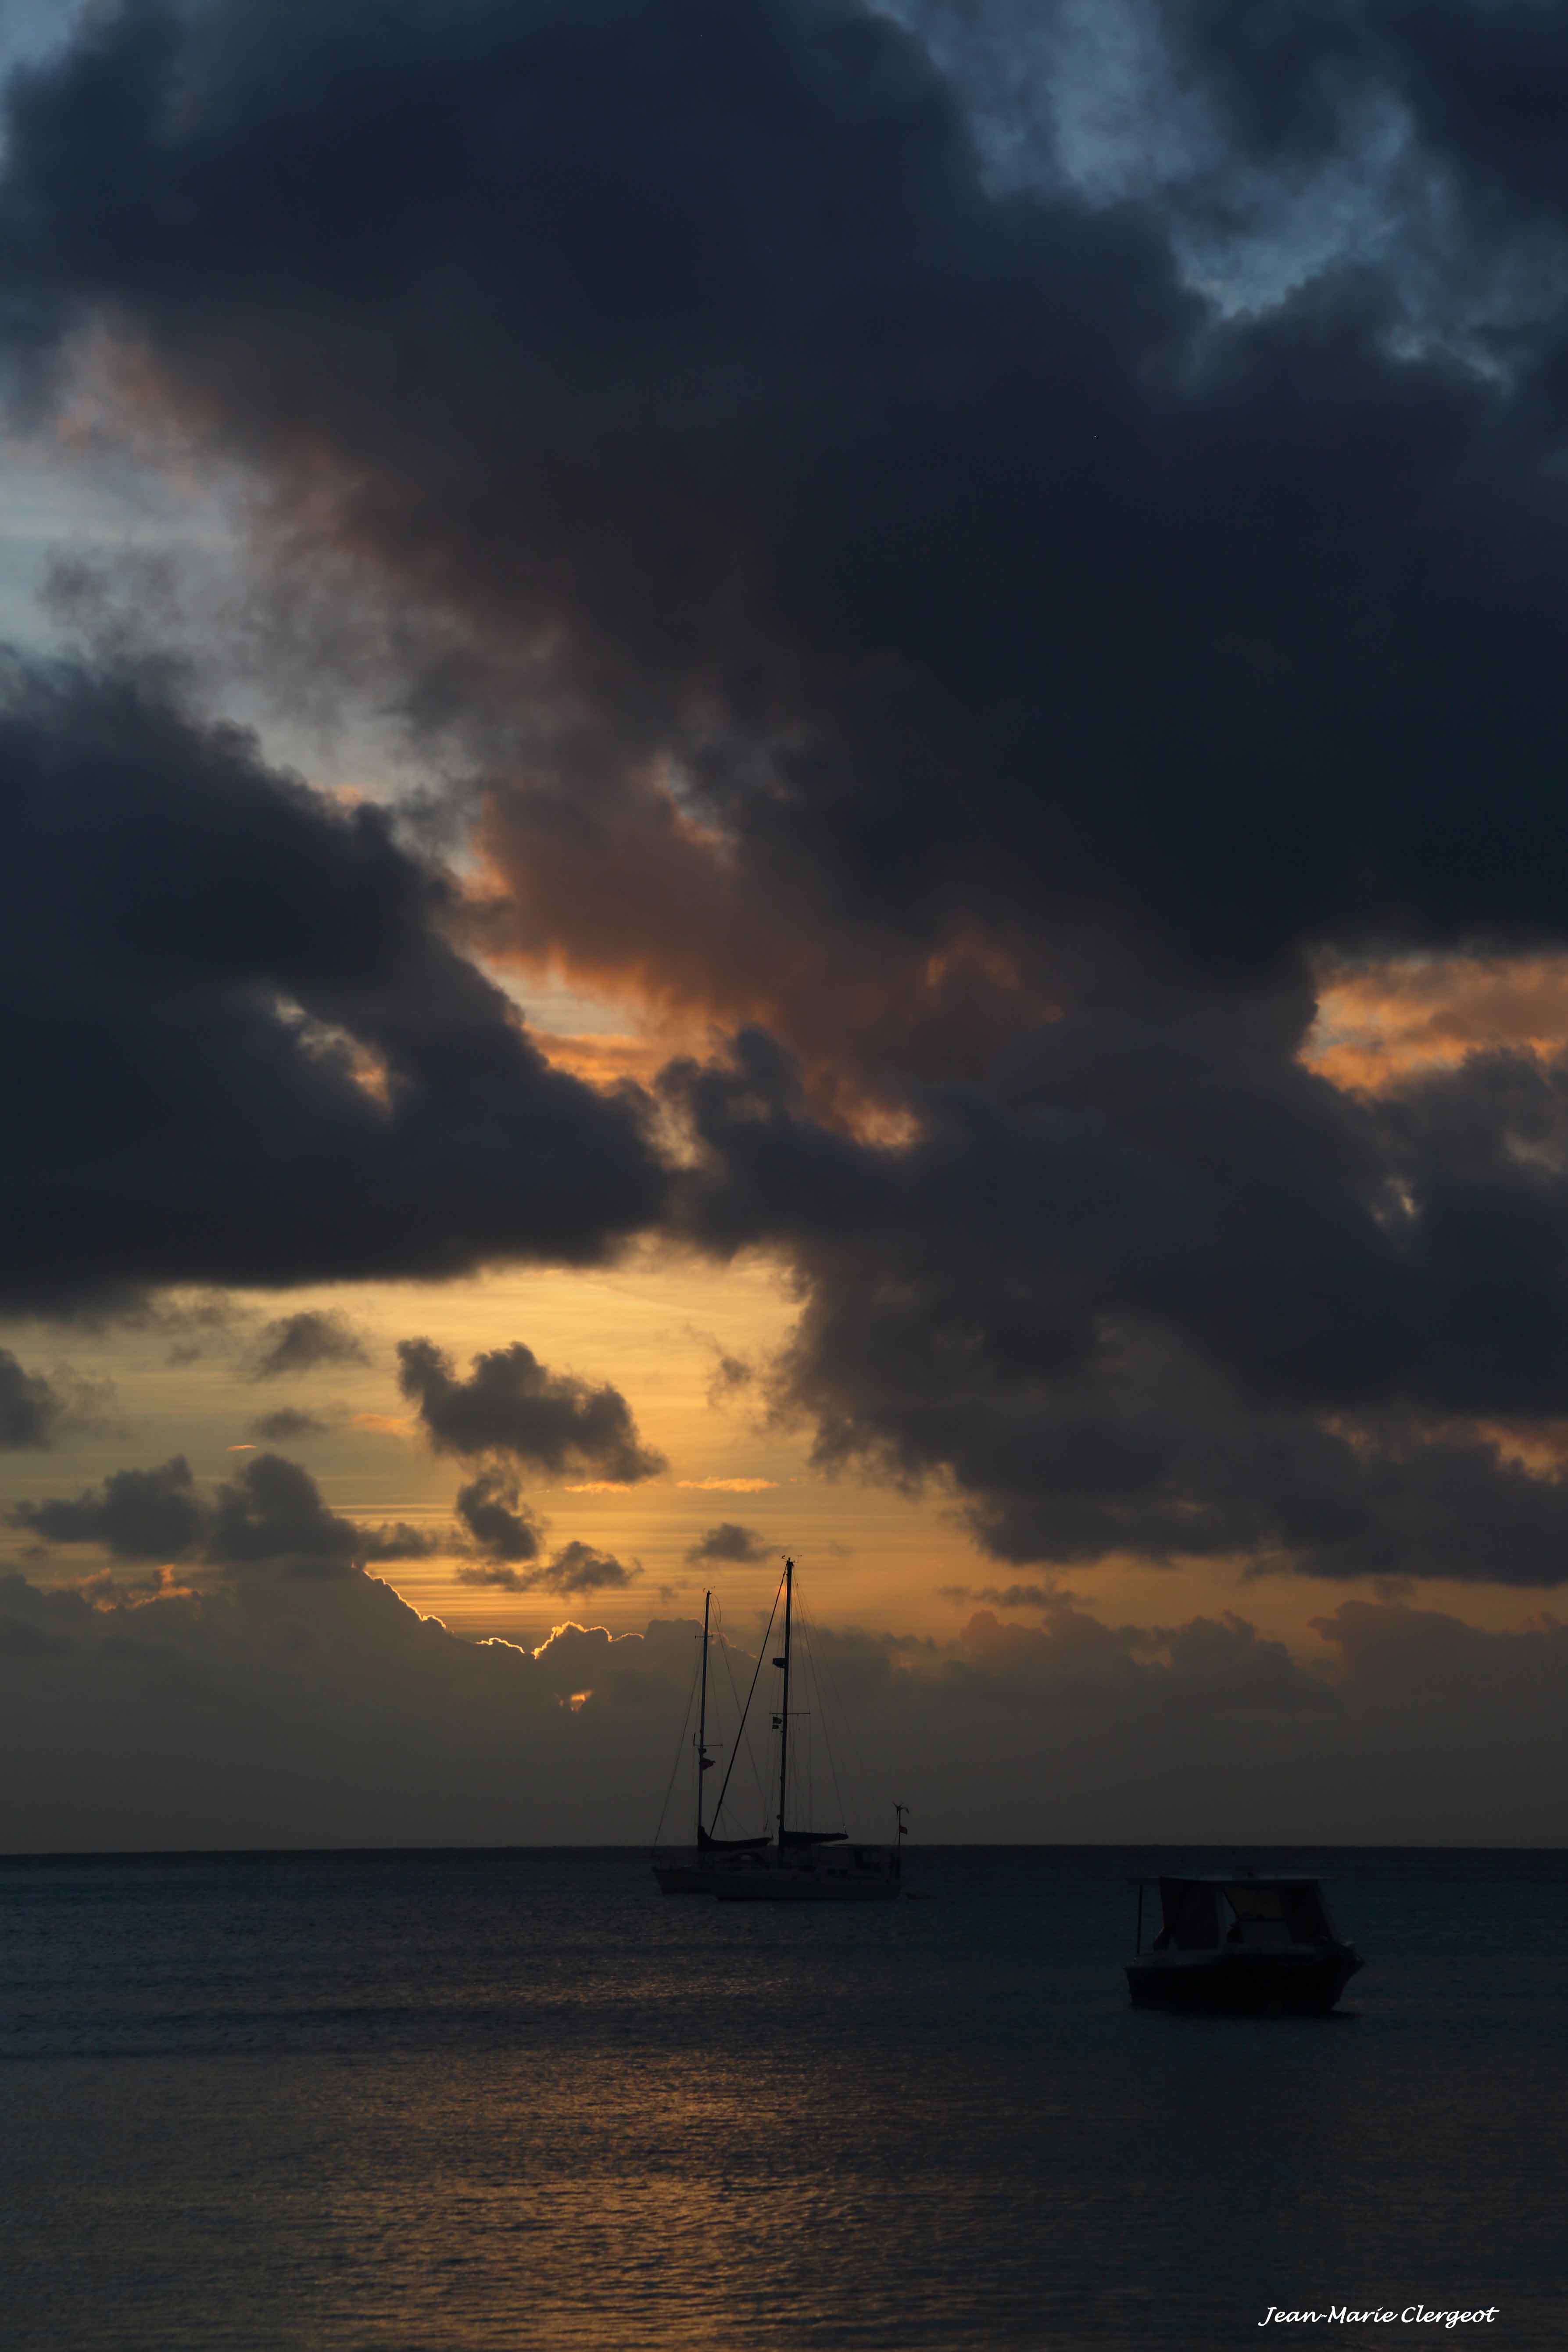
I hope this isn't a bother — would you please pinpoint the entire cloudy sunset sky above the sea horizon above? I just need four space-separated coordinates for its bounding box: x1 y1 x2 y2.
0 0 1568 1851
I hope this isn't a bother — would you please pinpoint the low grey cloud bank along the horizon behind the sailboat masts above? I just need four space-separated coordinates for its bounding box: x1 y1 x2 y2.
0 1566 1568 1851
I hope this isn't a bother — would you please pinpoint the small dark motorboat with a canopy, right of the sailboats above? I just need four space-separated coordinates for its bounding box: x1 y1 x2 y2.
1126 1870 1364 2018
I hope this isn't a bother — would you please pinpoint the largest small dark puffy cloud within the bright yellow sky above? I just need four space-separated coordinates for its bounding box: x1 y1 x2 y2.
397 1338 665 1486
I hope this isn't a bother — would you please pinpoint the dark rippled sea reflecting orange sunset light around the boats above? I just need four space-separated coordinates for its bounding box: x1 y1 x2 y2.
0 1846 1568 2352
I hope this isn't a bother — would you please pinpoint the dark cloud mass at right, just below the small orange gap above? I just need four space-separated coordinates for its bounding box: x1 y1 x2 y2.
668 1021 1568 1585
